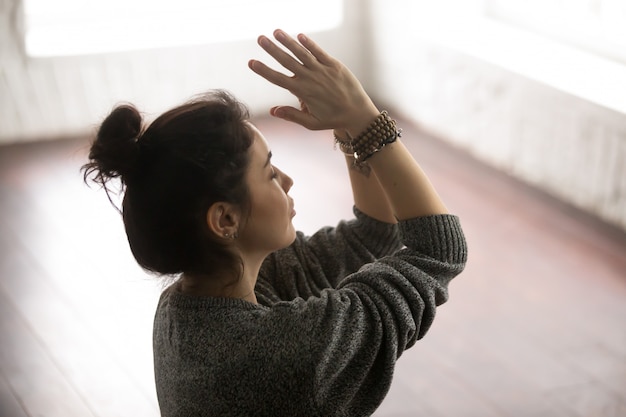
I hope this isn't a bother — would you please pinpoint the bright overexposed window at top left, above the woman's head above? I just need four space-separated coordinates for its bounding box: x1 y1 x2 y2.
24 0 343 57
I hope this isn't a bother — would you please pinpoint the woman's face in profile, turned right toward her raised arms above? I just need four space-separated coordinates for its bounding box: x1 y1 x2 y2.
238 124 296 256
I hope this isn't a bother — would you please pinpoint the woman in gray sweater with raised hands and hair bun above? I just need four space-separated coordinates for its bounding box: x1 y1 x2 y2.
85 30 466 417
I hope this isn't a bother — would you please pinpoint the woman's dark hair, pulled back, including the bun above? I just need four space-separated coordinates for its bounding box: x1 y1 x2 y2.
82 90 253 276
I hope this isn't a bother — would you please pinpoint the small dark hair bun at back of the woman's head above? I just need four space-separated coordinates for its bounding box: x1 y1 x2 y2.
83 105 142 185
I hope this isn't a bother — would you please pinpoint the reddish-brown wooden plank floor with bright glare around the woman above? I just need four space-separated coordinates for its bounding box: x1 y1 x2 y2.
0 114 626 417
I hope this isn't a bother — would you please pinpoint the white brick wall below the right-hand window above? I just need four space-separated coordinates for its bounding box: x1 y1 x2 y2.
369 0 626 230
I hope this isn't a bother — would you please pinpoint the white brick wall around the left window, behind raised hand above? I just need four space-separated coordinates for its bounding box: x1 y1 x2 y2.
0 0 367 143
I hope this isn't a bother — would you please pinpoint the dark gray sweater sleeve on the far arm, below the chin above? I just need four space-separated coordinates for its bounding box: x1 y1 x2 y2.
256 207 402 305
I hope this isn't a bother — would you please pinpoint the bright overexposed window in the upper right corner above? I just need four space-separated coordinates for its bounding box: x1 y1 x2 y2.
406 0 626 114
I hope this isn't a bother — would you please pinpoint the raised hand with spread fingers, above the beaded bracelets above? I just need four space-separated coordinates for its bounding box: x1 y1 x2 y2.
248 30 380 136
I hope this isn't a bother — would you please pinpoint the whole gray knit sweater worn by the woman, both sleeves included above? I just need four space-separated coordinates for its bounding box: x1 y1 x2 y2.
154 209 467 417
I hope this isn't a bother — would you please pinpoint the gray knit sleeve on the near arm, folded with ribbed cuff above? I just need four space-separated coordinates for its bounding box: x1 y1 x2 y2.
272 215 467 415
